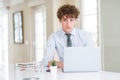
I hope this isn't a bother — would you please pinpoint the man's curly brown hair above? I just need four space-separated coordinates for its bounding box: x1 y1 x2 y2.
57 4 80 20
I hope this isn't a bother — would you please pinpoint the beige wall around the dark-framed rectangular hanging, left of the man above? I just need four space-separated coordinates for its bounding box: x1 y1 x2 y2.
8 0 43 64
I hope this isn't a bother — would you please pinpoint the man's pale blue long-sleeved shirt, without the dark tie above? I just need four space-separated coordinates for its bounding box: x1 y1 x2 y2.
43 28 94 66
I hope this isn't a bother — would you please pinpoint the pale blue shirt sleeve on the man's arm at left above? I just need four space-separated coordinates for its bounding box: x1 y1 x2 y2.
43 34 55 66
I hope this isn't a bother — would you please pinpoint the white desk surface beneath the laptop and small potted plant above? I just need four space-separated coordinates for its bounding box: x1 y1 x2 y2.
10 64 120 80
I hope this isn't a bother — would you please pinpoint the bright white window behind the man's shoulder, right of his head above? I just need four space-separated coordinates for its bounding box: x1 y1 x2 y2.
80 0 99 46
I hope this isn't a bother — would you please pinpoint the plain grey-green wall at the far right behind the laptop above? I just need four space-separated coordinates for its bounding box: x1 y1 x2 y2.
100 0 120 72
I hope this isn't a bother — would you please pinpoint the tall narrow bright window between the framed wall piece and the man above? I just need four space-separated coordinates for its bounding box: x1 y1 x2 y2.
34 4 46 61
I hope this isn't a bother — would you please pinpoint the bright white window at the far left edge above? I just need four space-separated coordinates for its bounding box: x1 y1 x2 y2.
0 9 8 80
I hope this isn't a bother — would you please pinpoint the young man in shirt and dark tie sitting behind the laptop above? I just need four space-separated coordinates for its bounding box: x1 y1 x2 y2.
43 4 94 68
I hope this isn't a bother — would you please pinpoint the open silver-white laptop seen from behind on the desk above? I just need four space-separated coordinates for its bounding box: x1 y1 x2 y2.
63 47 101 72
